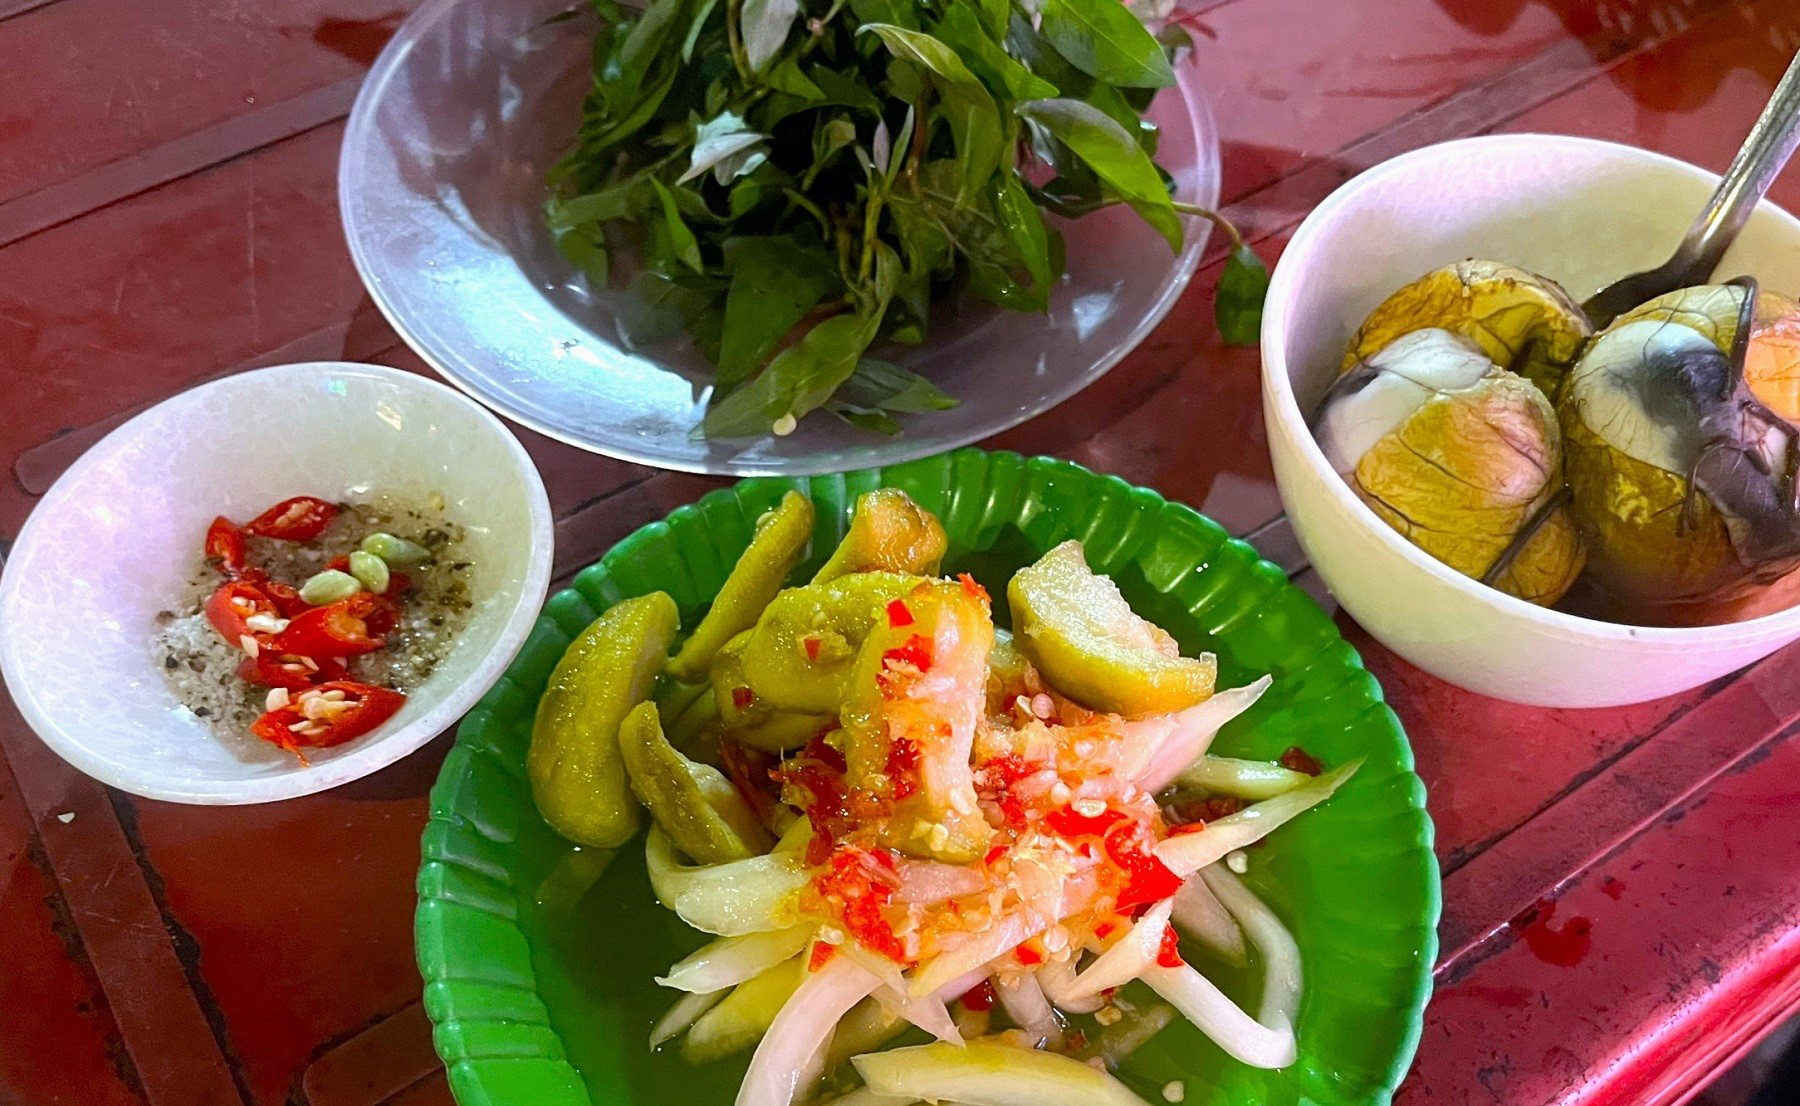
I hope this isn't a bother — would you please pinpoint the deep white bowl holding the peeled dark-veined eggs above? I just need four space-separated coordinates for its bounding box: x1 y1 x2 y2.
1262 135 1800 706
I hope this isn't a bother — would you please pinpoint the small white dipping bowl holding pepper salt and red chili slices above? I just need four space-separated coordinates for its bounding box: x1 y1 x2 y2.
0 362 551 803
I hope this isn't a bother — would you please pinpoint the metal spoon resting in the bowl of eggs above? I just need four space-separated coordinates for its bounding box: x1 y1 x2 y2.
1580 56 1800 330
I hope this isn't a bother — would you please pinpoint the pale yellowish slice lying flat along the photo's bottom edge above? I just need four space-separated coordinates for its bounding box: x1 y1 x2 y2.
850 1041 1145 1106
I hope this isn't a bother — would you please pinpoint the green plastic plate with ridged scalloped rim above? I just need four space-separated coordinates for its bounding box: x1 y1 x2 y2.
418 449 1440 1106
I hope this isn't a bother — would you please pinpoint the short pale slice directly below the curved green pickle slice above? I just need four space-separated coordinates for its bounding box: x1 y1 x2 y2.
644 827 808 937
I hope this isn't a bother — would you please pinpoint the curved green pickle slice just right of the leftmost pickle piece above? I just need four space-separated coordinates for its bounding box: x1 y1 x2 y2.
619 703 772 865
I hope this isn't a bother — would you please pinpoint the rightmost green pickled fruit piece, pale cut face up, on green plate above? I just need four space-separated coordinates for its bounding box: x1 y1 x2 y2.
1006 542 1219 717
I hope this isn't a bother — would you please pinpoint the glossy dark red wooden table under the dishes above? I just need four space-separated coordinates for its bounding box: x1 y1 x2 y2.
0 0 1800 1106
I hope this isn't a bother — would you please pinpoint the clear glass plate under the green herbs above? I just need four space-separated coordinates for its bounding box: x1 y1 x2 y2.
338 0 1219 476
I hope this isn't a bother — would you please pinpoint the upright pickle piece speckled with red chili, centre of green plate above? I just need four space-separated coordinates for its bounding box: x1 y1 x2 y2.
842 580 994 863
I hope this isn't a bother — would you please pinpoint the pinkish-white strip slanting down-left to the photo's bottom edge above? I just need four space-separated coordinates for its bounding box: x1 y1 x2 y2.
736 956 882 1106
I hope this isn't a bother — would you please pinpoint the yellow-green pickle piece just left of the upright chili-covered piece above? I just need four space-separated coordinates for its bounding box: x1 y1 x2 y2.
738 571 922 730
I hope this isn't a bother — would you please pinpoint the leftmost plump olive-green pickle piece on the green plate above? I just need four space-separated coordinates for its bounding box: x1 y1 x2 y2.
526 591 680 848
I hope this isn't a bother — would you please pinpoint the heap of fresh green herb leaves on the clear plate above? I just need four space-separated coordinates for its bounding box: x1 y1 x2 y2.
545 0 1267 438
